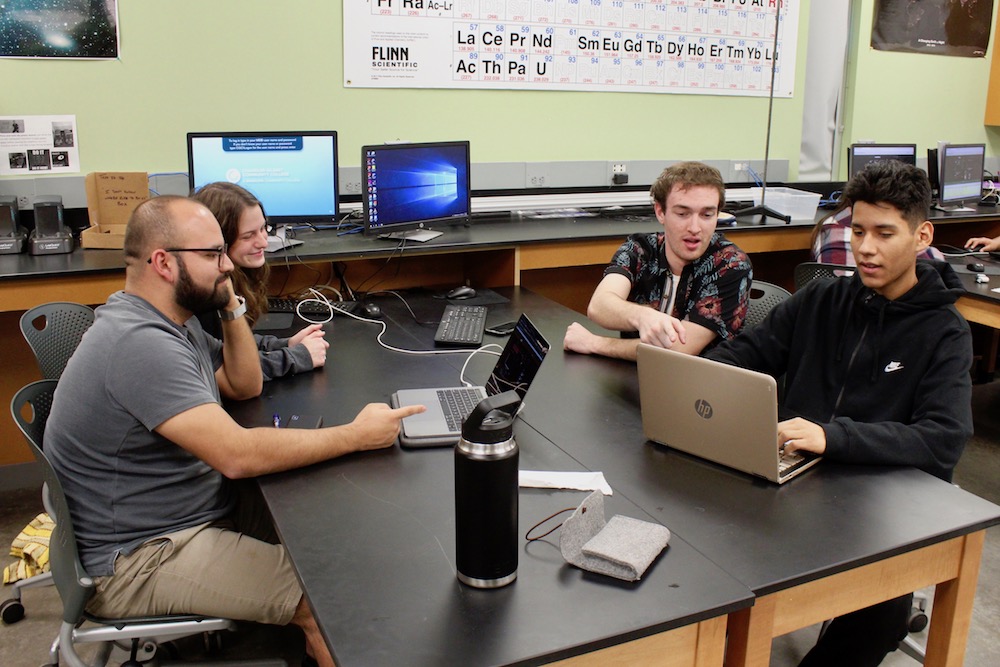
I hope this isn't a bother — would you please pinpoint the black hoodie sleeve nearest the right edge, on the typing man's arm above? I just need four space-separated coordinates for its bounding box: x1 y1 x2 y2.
823 328 973 481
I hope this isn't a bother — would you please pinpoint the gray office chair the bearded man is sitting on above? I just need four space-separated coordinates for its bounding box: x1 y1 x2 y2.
10 380 236 667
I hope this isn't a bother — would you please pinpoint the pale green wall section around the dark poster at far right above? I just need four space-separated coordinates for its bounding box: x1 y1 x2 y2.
842 0 1000 175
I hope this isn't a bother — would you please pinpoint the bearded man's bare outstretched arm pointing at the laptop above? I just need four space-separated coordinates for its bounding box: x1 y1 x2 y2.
155 402 425 479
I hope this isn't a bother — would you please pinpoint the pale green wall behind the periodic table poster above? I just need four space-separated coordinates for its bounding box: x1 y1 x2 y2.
0 0 809 175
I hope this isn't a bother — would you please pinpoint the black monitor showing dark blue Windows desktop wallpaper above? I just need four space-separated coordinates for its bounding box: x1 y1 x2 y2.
361 141 472 241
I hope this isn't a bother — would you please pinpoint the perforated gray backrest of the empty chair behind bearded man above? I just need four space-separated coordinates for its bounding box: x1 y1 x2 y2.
21 301 94 380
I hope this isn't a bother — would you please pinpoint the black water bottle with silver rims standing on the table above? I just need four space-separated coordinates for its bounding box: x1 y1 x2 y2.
455 391 521 588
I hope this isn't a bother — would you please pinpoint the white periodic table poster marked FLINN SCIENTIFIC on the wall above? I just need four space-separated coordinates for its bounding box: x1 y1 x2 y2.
344 0 800 97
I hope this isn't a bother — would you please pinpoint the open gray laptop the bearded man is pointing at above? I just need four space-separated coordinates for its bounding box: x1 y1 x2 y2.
390 315 549 447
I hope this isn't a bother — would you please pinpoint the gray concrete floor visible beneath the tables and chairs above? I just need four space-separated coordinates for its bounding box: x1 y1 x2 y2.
0 381 1000 667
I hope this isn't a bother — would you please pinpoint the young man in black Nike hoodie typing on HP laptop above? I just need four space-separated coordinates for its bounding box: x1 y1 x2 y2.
705 162 972 667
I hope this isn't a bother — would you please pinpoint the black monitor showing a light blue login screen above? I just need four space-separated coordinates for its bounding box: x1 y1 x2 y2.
187 130 339 225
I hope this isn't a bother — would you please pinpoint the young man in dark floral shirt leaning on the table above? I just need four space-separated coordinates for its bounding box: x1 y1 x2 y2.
563 162 753 361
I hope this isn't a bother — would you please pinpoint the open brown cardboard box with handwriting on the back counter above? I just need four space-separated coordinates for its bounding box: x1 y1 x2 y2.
80 171 149 248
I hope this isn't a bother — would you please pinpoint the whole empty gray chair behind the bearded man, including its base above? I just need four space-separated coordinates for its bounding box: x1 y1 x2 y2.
0 301 94 625
